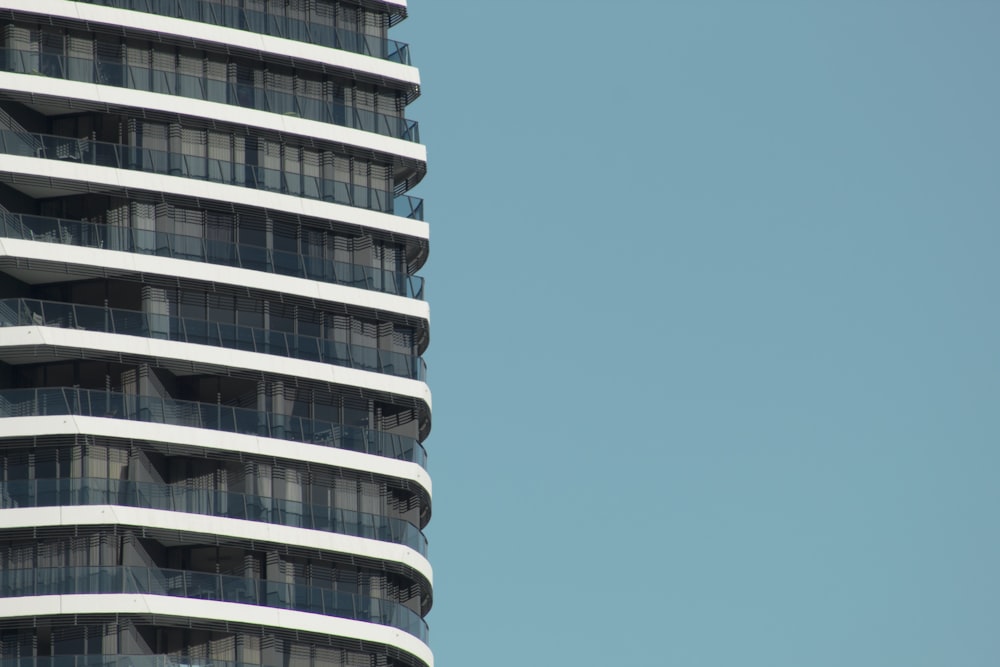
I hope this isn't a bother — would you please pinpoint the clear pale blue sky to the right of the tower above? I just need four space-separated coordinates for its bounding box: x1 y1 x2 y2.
395 0 1000 667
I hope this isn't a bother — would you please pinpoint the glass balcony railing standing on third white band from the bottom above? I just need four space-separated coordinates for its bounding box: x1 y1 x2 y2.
0 387 427 468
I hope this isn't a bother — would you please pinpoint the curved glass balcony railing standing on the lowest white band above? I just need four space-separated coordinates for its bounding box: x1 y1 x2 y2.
0 566 428 642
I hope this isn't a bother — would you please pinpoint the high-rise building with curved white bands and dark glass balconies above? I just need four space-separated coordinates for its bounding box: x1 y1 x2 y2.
0 0 433 667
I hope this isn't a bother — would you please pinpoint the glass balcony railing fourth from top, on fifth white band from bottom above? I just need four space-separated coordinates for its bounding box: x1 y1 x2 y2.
0 211 424 300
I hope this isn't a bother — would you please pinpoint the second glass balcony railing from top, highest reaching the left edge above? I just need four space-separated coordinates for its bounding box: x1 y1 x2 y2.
0 49 420 143
